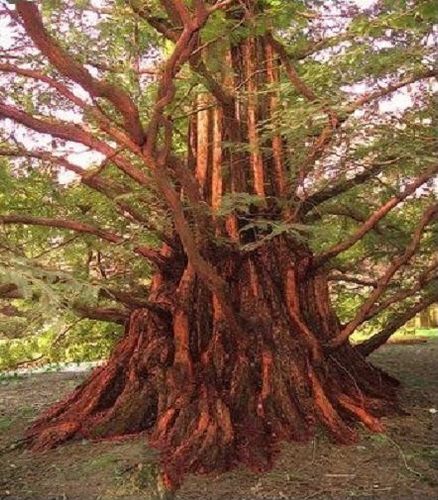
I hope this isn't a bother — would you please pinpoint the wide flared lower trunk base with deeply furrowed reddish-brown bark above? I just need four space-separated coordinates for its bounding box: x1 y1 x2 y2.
28 237 396 484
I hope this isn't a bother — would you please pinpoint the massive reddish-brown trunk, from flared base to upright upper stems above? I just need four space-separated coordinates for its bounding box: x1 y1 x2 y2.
24 32 396 484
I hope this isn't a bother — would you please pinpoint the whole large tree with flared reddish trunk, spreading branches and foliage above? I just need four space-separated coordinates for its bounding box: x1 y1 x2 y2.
0 0 438 484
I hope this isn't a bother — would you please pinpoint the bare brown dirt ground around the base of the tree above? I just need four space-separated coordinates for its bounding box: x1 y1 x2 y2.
0 340 438 500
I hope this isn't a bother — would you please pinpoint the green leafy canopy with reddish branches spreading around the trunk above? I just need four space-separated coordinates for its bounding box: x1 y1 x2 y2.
0 0 438 368
